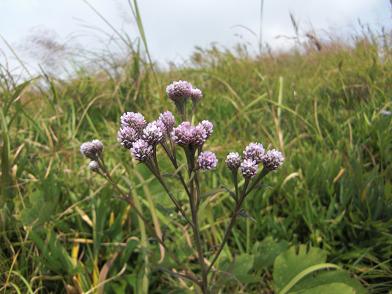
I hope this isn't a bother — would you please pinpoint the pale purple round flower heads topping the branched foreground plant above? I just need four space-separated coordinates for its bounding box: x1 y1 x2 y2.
80 80 285 184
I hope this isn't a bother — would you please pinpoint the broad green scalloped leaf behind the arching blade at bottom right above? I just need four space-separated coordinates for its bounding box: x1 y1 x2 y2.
273 245 327 292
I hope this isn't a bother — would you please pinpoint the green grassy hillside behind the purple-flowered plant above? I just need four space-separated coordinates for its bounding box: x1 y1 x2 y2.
0 31 392 293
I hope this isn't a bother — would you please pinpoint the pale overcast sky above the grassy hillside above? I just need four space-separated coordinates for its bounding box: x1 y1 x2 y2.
0 0 392 76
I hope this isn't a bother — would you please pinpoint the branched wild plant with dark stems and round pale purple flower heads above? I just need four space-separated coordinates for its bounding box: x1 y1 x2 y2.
80 81 284 293
